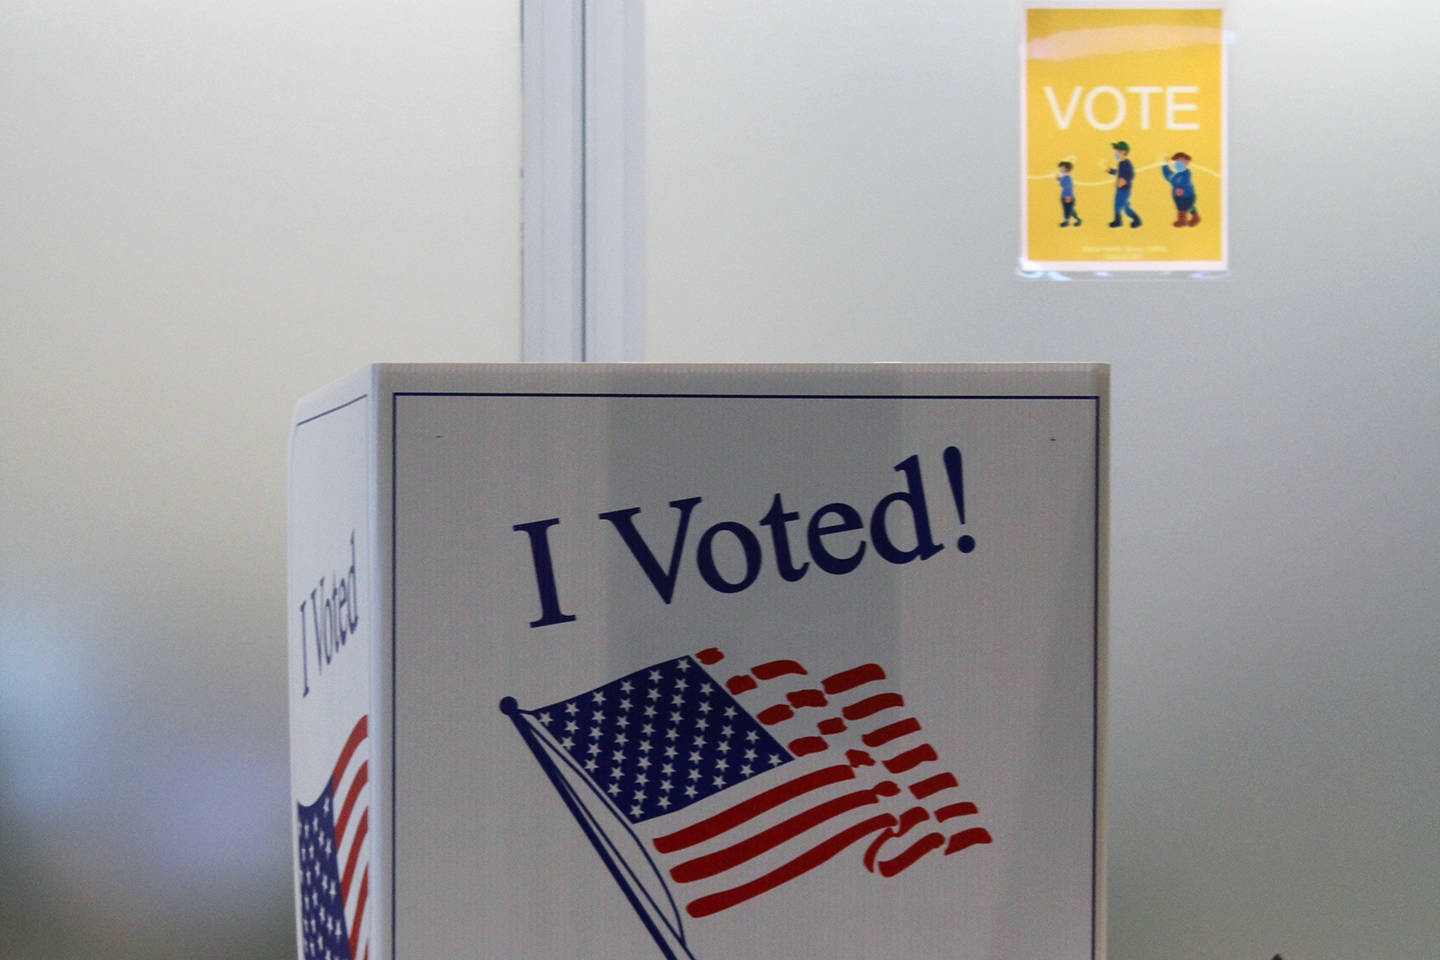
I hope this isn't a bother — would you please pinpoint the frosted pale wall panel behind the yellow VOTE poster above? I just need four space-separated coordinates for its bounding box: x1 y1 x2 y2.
645 0 1440 960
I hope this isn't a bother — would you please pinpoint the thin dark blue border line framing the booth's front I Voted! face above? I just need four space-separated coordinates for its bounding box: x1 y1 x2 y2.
388 390 1102 960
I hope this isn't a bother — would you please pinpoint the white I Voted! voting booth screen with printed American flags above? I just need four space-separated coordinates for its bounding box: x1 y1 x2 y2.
288 364 1109 960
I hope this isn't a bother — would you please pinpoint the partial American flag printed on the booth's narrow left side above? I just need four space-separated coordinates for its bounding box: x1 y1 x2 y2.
297 717 370 960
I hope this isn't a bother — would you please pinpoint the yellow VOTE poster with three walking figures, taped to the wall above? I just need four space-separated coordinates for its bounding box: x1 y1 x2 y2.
1021 6 1228 273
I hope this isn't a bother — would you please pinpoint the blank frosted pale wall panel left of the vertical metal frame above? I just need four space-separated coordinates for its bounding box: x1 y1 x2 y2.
0 0 520 959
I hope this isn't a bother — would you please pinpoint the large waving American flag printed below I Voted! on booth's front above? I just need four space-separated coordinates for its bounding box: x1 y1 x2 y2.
501 649 991 960
